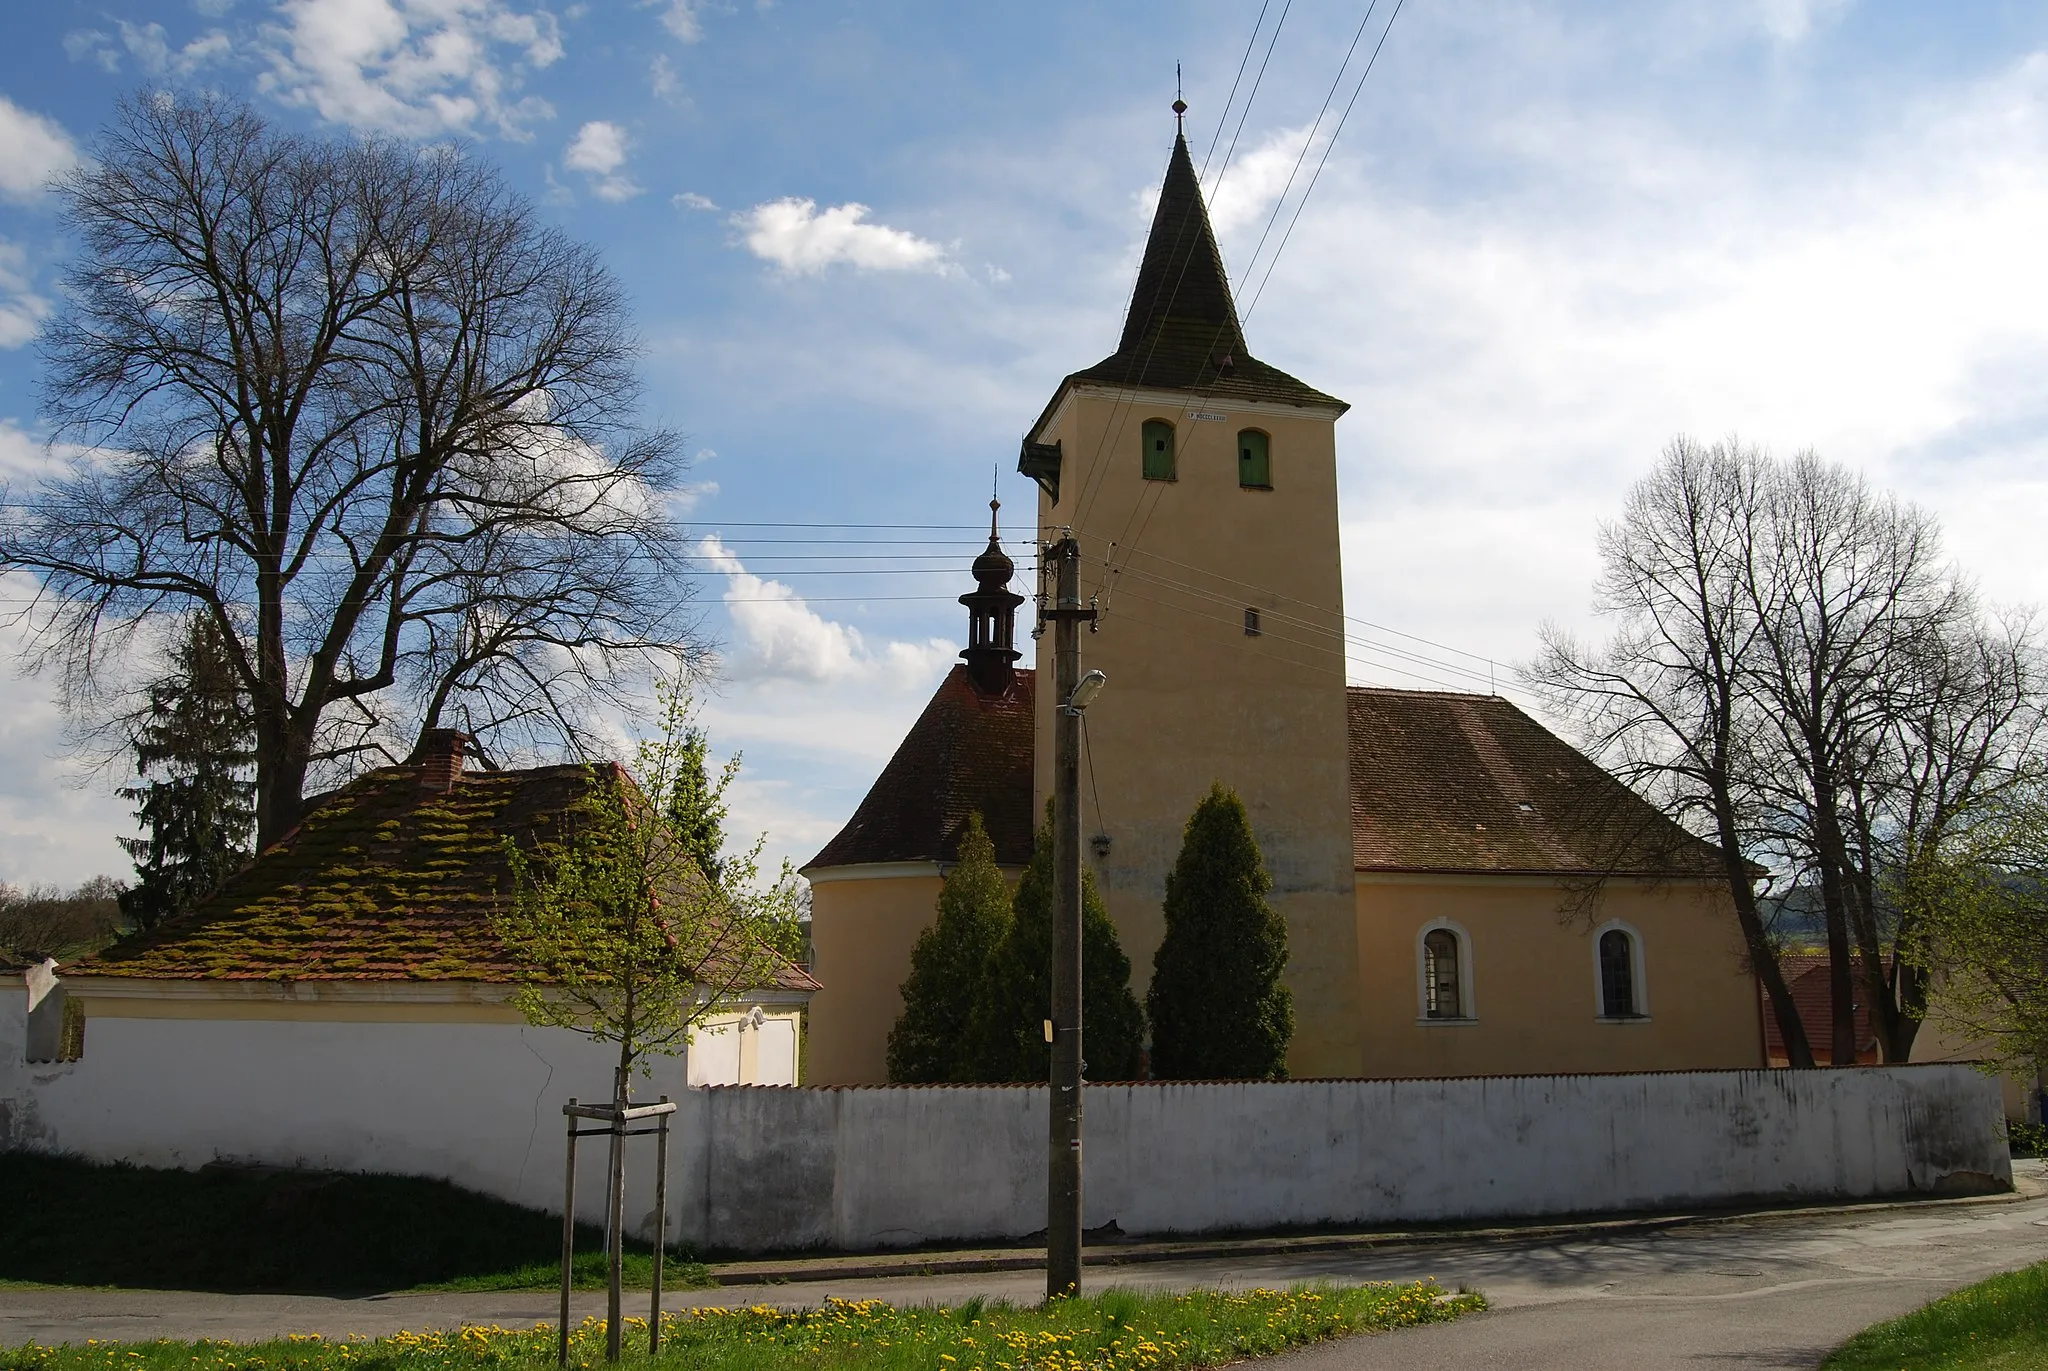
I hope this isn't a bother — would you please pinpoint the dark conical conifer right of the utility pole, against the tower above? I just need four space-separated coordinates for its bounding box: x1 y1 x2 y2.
1145 781 1294 1080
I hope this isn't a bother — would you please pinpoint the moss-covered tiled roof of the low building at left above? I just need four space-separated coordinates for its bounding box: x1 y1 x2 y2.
66 764 817 990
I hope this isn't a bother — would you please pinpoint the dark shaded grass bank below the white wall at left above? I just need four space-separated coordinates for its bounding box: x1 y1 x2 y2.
0 1152 711 1293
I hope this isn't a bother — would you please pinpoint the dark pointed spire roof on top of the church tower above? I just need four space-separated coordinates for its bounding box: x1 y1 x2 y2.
1032 137 1348 444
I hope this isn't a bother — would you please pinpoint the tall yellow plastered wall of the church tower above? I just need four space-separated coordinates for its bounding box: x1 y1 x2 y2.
1032 387 1364 1076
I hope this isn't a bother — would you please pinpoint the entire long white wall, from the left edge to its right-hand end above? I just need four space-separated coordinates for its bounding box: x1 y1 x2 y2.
0 994 2011 1250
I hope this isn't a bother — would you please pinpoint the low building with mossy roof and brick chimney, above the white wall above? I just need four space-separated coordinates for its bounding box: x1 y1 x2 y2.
63 730 817 1082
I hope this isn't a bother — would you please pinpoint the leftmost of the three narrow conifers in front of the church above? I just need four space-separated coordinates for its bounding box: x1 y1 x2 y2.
889 814 1012 1084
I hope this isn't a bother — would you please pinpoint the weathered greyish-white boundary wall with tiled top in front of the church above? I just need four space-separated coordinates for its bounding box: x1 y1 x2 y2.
672 1066 2011 1250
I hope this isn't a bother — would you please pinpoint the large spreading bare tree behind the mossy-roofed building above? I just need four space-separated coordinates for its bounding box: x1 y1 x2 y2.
0 92 696 844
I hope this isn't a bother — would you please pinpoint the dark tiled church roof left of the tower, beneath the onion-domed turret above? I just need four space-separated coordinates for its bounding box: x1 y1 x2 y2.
805 666 1034 869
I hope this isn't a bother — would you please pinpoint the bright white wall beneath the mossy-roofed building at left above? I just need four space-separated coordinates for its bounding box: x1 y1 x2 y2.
0 996 686 1221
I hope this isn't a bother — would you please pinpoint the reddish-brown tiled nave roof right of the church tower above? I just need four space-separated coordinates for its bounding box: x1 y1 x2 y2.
1350 687 1716 875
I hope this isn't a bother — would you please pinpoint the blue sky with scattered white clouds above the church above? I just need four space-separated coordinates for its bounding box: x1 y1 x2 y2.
0 0 2048 883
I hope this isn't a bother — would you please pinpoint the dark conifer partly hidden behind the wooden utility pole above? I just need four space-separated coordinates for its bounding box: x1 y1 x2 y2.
971 805 1145 1080
